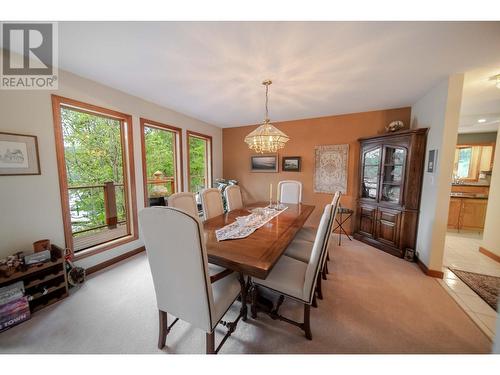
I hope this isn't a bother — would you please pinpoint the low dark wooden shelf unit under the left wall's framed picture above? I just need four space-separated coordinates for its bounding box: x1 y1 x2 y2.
0 245 68 313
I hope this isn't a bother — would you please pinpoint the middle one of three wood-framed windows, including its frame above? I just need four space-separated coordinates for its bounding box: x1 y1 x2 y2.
141 118 182 206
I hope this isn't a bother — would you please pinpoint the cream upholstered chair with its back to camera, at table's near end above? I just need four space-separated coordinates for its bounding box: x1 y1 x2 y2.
139 207 246 353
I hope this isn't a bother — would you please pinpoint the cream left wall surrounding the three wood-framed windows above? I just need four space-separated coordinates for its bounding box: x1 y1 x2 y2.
0 66 222 267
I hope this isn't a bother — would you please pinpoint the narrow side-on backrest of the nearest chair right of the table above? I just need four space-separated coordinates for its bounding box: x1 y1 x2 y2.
303 204 333 303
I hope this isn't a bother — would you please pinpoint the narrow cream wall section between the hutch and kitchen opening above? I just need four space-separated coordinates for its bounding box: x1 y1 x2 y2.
412 74 463 271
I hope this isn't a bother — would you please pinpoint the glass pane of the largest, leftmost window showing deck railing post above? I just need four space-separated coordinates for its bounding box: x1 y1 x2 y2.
61 107 129 251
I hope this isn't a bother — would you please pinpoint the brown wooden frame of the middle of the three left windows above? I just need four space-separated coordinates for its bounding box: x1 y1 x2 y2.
139 117 184 207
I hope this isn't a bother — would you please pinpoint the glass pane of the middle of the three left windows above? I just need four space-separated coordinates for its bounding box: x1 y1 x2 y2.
144 126 176 205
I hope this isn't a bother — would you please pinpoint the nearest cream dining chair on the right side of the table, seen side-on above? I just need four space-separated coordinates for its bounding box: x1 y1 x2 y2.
251 204 332 340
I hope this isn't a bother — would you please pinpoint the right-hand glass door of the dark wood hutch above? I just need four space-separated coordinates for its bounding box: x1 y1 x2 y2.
380 146 406 203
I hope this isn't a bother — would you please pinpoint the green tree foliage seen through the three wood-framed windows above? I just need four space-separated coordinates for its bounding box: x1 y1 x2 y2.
61 108 207 232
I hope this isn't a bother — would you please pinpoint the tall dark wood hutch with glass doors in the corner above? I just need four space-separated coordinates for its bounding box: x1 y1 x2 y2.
354 128 428 257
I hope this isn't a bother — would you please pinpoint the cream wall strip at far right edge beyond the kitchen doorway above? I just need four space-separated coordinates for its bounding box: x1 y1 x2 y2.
482 132 500 256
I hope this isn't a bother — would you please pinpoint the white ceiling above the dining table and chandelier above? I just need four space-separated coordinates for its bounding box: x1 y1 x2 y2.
39 22 500 127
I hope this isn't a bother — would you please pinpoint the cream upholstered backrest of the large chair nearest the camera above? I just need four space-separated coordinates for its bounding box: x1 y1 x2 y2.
139 207 214 332
